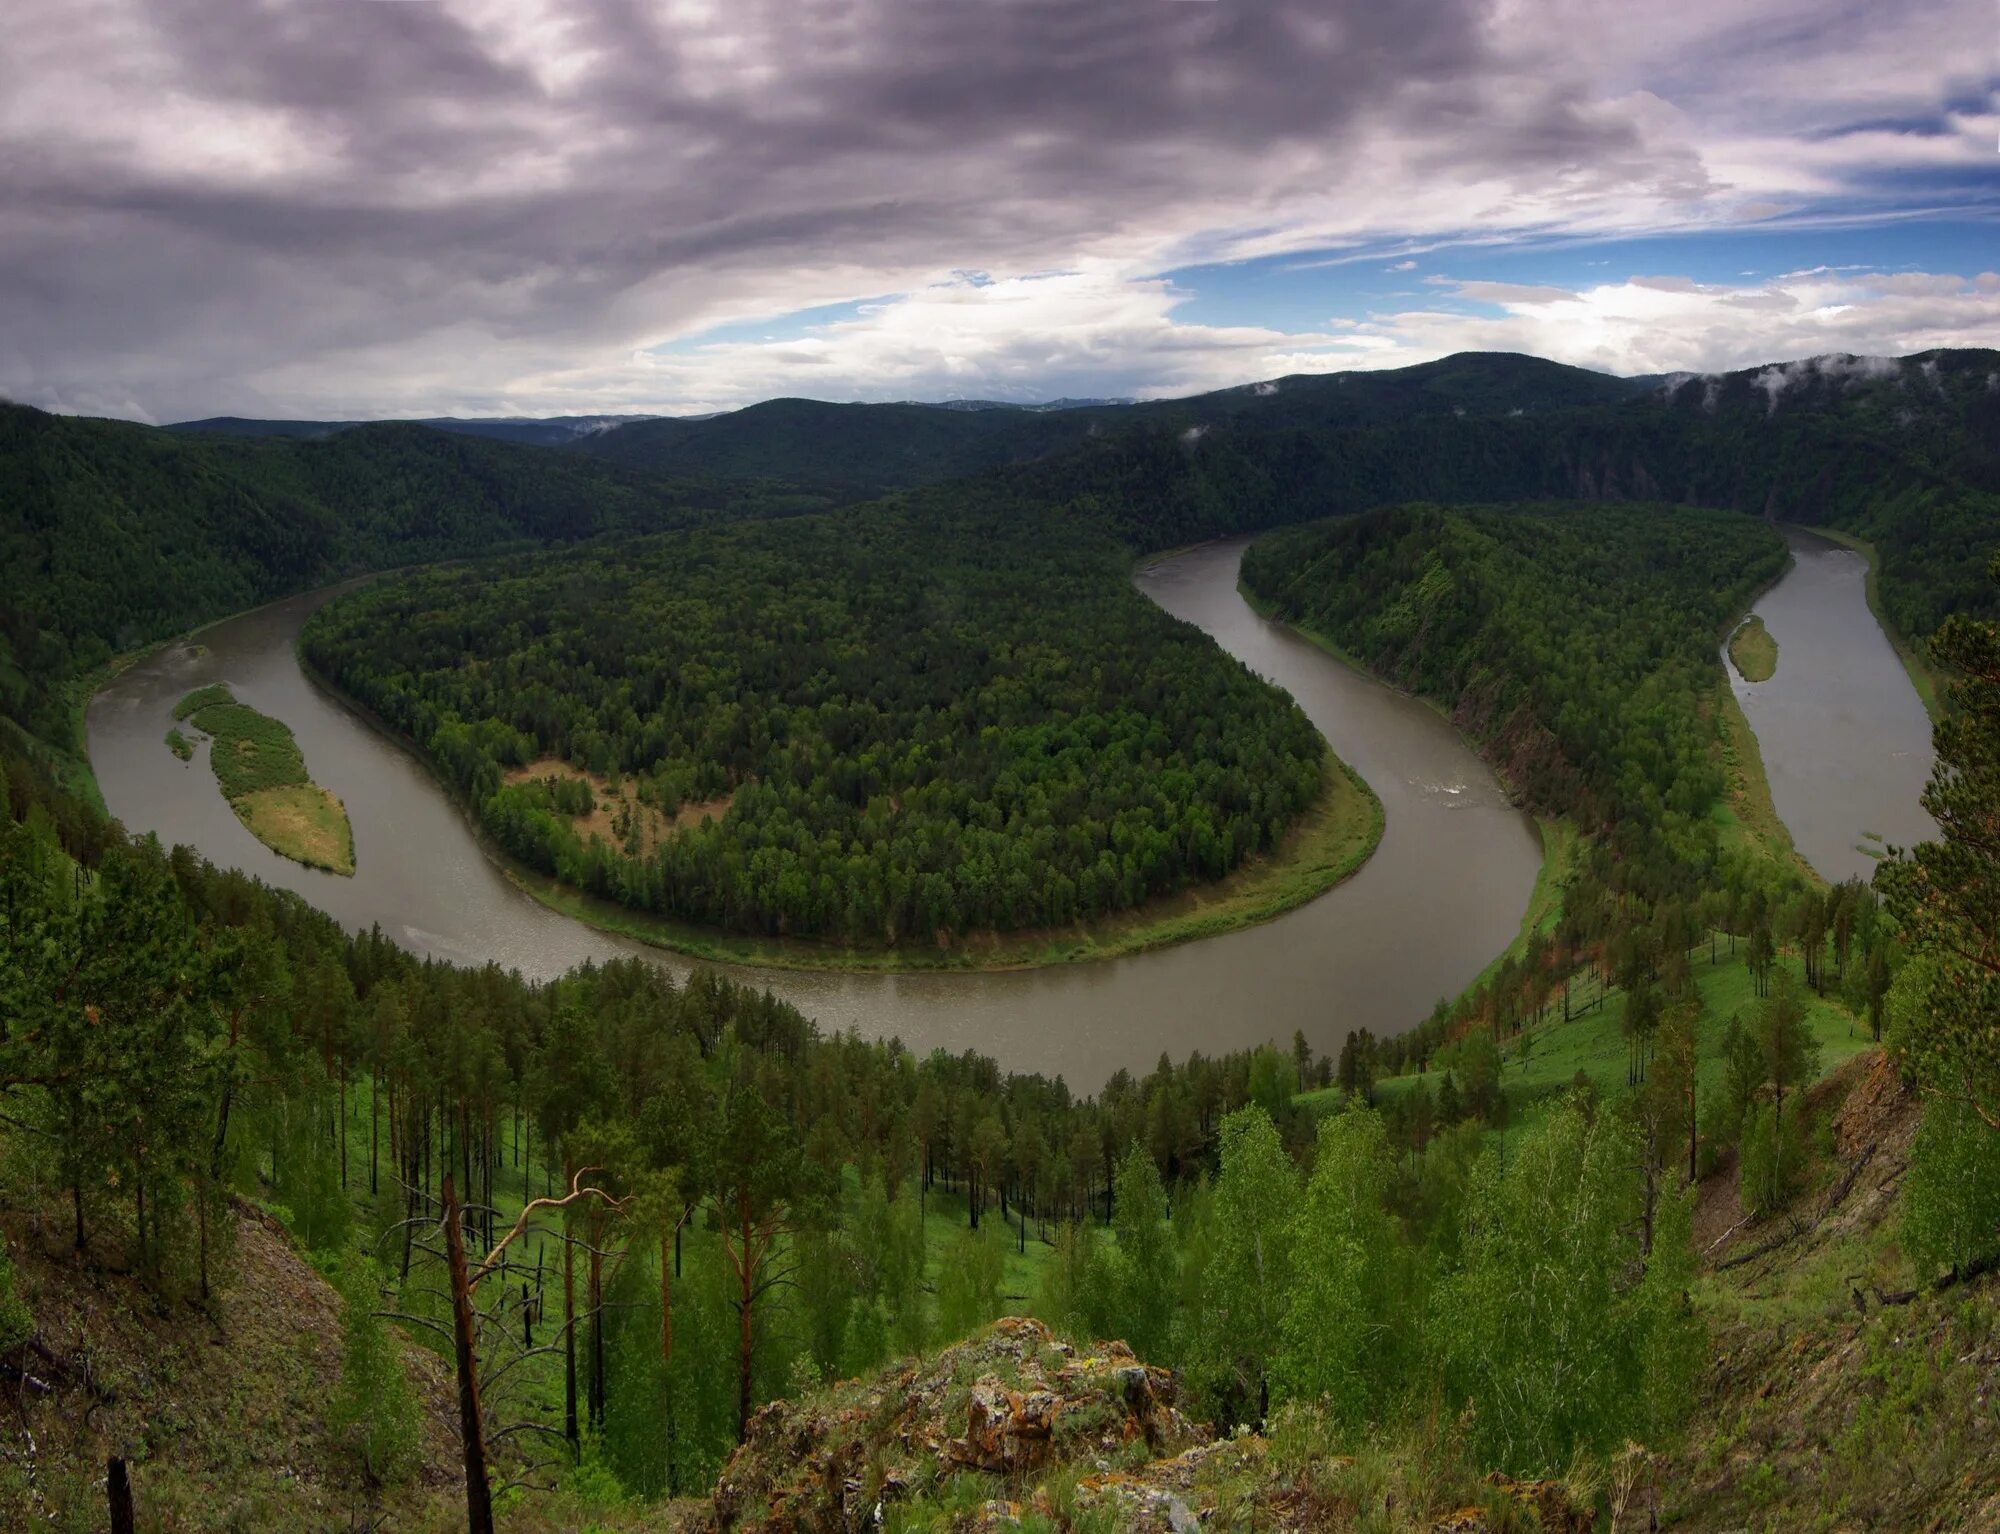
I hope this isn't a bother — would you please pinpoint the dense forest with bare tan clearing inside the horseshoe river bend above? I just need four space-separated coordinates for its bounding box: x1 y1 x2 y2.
302 496 1328 942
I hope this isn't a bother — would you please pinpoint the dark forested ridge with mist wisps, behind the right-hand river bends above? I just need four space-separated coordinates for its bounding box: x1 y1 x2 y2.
956 350 2000 640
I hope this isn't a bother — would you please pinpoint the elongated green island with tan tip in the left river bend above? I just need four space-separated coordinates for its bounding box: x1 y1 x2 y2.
168 686 354 874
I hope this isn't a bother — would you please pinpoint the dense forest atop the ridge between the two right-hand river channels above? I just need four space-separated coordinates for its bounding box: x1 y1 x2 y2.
1242 504 1790 898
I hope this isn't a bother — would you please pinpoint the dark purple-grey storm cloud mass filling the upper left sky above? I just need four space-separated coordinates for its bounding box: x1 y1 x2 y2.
0 0 1698 416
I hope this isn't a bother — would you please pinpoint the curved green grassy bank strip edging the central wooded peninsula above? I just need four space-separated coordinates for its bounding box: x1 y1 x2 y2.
508 748 1382 972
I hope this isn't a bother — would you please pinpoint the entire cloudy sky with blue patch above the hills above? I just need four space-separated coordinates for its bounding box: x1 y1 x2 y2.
0 0 2000 422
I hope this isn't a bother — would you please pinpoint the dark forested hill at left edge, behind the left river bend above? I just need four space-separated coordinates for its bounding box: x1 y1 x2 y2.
0 404 798 752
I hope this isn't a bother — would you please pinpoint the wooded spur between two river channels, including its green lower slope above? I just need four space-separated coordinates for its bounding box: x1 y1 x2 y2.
1242 504 1898 1088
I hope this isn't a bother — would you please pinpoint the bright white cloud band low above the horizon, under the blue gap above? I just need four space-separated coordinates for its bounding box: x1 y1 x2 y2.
296 264 2000 412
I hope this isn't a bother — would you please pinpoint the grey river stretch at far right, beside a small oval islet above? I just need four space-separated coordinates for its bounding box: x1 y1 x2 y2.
1728 528 1938 882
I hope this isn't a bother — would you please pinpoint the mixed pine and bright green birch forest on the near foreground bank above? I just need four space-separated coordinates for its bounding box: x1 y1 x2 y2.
0 712 1700 1510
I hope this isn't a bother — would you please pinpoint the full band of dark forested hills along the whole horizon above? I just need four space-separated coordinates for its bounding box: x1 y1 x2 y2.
0 350 2000 760
